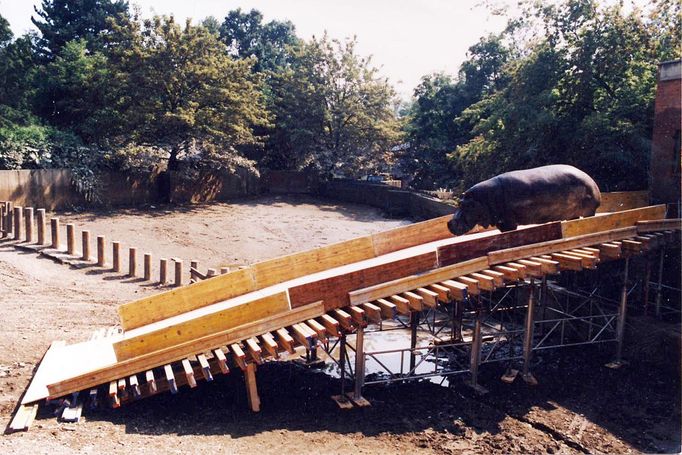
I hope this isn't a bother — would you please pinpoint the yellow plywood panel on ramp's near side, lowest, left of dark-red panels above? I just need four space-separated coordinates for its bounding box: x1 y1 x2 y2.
114 292 289 361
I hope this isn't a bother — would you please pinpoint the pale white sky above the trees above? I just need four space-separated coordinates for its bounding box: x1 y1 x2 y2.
0 0 646 97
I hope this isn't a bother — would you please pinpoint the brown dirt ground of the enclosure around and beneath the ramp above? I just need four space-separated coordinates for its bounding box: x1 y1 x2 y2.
0 197 681 454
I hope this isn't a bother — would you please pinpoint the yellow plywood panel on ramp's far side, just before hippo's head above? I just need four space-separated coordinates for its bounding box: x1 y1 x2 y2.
372 215 455 256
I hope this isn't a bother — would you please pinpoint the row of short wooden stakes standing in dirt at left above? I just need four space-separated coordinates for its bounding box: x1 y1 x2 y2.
0 201 230 286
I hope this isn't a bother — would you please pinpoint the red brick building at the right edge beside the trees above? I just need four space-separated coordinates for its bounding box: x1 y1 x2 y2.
650 60 682 216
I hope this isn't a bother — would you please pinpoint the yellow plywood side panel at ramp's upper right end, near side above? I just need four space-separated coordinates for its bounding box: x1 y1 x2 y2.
561 205 665 239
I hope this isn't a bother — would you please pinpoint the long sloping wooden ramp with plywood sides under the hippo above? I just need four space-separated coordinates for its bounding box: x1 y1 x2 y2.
11 206 680 430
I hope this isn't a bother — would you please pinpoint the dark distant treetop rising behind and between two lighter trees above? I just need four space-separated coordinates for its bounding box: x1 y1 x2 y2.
220 8 300 72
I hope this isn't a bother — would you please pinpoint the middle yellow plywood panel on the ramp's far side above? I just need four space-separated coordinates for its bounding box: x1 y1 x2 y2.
251 236 374 289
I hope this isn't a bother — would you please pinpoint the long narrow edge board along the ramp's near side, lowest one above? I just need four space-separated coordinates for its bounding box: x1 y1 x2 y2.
46 302 325 400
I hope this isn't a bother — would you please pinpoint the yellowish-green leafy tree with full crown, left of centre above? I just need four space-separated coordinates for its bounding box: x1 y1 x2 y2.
111 16 266 170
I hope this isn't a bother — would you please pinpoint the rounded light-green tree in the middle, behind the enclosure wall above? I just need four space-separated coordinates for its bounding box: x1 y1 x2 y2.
265 35 401 176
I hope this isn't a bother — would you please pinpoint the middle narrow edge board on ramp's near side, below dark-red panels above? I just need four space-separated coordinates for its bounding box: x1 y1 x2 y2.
349 257 488 304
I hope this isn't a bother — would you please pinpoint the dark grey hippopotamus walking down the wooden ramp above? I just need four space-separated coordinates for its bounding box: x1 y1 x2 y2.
448 164 601 235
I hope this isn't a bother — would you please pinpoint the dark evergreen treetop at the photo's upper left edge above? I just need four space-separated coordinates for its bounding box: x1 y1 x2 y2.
31 0 128 60
